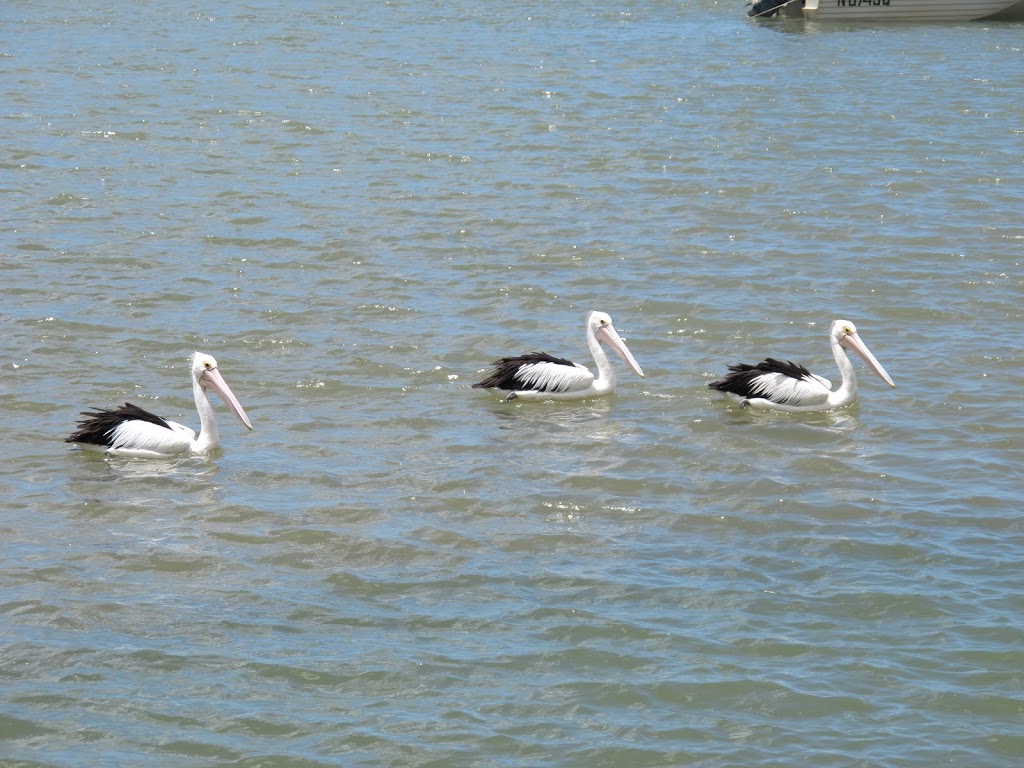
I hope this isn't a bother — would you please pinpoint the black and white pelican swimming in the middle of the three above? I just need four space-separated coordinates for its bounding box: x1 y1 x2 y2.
473 312 643 400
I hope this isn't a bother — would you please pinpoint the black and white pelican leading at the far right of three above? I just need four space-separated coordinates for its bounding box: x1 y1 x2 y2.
708 321 896 412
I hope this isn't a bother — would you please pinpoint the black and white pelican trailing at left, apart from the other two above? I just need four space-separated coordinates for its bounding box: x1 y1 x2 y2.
65 352 253 459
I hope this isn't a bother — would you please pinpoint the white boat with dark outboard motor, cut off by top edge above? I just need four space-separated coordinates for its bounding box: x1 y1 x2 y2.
746 0 1024 22
